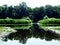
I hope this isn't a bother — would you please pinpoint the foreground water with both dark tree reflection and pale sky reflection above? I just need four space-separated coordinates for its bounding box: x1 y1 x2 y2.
0 24 60 45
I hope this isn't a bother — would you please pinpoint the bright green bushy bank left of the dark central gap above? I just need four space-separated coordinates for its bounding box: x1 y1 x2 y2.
0 18 32 24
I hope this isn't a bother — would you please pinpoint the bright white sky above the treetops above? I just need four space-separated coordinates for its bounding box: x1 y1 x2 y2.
0 0 60 8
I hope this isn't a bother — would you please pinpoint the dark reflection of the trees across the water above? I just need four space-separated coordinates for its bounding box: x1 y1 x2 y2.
1 24 60 44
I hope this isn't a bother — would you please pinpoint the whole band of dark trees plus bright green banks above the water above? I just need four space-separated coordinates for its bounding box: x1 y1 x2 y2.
0 2 60 29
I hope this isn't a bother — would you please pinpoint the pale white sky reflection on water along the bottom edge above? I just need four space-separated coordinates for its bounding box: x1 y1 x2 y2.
0 38 60 45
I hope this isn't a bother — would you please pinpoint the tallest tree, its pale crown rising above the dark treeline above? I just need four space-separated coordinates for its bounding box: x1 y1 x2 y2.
19 2 29 17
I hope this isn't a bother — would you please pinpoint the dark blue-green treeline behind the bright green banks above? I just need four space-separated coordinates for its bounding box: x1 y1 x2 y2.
0 2 60 22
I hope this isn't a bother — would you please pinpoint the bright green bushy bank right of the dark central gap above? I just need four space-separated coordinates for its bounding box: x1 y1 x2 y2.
38 18 60 26
